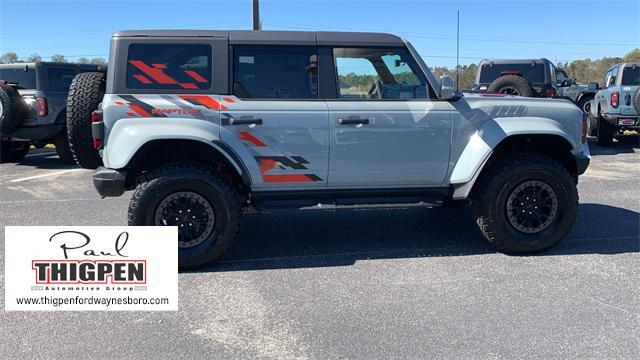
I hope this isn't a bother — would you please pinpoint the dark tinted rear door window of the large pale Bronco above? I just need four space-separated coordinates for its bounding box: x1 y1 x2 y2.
233 45 318 99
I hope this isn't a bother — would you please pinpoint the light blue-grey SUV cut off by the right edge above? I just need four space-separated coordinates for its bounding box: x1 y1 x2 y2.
589 63 640 146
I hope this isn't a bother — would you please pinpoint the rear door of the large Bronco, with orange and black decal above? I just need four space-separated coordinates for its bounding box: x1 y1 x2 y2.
221 45 329 189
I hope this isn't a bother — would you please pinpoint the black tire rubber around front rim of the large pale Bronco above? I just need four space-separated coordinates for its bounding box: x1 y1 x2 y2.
471 153 578 254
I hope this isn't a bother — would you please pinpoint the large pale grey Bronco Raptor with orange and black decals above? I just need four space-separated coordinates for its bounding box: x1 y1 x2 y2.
67 30 590 268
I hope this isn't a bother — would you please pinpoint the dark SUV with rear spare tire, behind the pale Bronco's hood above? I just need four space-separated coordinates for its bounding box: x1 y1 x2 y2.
473 58 598 114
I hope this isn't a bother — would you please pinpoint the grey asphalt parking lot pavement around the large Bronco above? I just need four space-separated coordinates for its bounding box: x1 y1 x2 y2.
0 136 640 359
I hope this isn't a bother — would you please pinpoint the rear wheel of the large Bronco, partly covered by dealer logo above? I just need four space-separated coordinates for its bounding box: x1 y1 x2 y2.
129 163 241 269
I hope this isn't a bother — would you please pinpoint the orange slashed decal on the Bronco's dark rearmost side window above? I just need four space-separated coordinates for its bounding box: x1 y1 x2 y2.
129 60 209 89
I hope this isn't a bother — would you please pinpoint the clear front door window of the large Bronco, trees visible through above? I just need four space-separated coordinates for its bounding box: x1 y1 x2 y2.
333 48 427 100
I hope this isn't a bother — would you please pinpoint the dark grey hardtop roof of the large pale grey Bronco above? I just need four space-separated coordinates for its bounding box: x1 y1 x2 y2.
113 30 404 46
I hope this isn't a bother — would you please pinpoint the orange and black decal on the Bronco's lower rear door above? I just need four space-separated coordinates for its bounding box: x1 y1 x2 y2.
238 131 322 183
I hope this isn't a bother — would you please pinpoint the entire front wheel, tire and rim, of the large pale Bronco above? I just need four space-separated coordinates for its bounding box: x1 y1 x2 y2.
471 153 578 254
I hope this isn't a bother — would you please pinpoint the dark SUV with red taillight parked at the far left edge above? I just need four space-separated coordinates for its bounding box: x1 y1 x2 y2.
0 62 106 163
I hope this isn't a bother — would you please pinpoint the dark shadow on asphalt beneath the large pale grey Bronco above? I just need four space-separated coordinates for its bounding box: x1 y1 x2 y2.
198 204 640 272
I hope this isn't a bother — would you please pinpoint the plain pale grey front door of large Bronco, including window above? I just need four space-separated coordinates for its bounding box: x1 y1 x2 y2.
327 48 451 187
